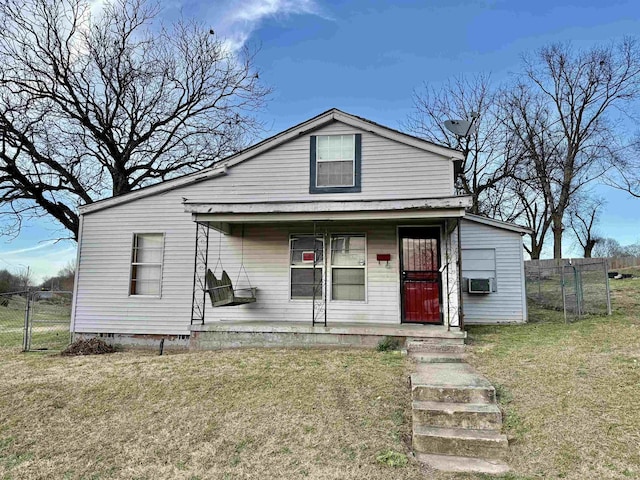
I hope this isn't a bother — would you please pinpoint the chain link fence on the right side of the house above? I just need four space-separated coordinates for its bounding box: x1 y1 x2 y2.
525 258 611 321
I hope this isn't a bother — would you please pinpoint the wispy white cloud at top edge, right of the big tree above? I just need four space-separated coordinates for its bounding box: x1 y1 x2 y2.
210 0 323 51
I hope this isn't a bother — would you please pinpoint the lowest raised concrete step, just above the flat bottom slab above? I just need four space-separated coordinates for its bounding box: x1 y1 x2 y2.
413 425 509 460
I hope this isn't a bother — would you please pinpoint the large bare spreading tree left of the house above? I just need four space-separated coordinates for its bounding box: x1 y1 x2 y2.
0 0 269 238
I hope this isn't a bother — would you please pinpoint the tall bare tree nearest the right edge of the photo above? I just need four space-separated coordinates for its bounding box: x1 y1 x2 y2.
518 39 640 258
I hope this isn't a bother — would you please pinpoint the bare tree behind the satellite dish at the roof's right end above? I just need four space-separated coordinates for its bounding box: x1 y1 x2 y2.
404 75 514 216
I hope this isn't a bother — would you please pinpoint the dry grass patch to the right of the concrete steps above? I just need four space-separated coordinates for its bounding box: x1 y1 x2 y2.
456 279 640 480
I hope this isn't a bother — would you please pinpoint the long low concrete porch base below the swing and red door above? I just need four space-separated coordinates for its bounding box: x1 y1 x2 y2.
189 321 467 350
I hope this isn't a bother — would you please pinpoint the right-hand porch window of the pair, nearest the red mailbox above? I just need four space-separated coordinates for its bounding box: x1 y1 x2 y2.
331 234 367 302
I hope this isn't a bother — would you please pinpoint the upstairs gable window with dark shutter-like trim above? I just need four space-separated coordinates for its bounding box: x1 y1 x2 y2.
309 133 362 193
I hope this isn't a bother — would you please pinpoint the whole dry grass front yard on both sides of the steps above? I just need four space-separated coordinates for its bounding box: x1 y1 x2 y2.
0 268 640 480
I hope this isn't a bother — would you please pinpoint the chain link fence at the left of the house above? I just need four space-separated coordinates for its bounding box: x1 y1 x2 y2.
0 291 72 351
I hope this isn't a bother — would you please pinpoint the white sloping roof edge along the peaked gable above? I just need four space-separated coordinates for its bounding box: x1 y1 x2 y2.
79 108 464 215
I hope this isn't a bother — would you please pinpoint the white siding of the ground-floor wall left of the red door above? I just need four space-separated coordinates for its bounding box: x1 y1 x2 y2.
74 208 400 335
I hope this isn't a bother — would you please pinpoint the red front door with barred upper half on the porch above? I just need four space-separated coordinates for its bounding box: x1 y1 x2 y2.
400 227 442 323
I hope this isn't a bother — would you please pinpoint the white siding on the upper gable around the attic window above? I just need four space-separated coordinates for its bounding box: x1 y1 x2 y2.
181 122 454 203
